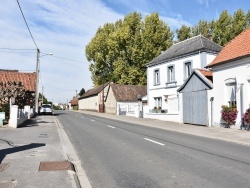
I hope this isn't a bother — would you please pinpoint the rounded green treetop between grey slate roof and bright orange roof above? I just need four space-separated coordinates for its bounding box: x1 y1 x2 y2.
213 10 232 46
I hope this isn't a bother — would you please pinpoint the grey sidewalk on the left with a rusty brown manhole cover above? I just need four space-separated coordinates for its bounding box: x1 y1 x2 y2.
0 116 85 188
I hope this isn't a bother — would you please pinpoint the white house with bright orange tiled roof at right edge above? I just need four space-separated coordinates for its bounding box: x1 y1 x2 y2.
207 28 250 128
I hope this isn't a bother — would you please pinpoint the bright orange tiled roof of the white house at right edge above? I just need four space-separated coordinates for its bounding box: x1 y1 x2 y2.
206 27 250 67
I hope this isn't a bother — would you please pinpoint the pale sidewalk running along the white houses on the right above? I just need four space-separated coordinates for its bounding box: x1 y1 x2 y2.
76 110 250 146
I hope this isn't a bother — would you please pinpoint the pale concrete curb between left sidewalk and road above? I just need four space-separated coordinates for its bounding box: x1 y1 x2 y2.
54 116 92 188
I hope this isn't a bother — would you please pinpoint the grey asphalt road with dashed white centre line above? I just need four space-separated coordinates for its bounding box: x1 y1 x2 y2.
55 111 250 188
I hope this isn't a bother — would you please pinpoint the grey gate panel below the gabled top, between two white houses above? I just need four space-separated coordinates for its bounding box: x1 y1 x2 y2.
183 90 208 125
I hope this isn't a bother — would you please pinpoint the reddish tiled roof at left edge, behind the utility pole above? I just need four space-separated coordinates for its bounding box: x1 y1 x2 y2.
0 69 36 92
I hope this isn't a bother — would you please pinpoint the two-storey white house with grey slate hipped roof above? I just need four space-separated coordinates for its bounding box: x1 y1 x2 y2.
144 35 222 122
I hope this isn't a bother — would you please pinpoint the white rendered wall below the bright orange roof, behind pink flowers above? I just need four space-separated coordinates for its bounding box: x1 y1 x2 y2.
213 58 250 128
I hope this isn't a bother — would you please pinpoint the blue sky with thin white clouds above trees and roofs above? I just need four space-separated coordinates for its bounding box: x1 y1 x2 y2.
0 0 250 103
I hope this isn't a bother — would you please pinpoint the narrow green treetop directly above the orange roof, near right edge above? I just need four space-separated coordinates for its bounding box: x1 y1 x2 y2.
231 9 246 39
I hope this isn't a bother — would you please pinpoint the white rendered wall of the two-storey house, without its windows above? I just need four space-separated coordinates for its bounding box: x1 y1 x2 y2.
146 52 216 122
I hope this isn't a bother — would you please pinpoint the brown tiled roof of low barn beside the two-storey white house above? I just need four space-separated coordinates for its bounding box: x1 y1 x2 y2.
110 84 147 102
